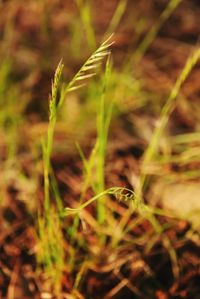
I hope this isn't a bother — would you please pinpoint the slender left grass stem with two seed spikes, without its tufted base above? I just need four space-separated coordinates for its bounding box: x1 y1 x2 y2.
43 37 112 218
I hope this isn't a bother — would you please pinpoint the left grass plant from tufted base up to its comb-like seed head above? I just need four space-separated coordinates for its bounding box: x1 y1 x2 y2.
38 37 112 293
